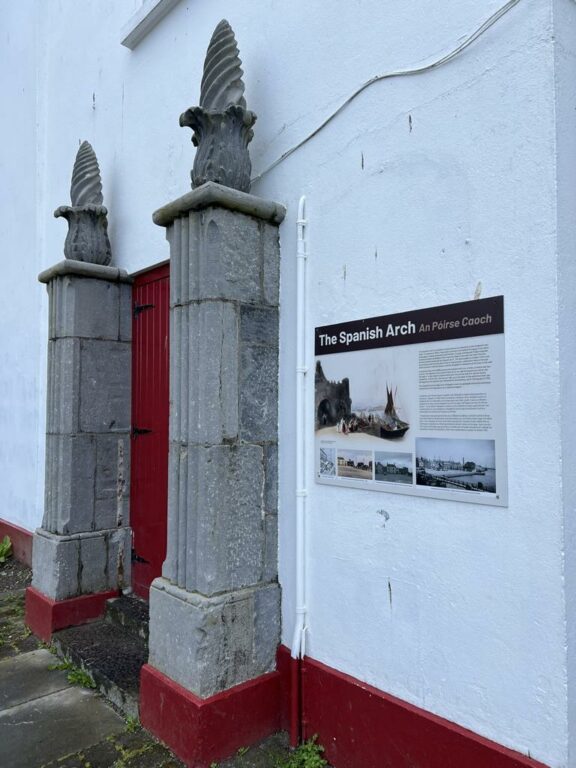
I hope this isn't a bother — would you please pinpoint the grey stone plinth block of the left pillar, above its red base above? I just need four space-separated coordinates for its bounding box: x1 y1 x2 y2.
32 527 132 601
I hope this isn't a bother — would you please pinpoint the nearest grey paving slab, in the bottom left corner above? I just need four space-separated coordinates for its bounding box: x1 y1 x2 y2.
0 680 125 768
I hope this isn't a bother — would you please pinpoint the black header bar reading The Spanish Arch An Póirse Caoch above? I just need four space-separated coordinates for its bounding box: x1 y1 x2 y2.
315 296 504 356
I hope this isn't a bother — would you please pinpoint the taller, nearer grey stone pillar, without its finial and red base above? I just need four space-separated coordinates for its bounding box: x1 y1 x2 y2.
149 182 284 697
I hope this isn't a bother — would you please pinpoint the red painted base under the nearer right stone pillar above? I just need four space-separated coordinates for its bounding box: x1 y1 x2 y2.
140 664 281 768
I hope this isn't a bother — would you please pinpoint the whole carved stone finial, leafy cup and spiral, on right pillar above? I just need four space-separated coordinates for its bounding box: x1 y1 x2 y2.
180 20 256 192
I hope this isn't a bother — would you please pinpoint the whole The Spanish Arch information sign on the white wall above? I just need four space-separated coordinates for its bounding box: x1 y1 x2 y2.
314 297 507 506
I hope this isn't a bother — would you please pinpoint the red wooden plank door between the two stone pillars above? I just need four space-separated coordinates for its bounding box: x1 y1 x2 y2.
130 264 170 599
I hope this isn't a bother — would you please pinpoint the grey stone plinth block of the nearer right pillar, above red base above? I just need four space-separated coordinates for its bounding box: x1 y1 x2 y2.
150 578 280 698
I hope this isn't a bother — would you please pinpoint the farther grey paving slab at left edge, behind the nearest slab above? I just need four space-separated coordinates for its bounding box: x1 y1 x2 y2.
0 650 69 713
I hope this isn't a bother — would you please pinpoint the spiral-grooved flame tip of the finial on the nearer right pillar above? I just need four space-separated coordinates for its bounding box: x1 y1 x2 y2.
200 19 246 112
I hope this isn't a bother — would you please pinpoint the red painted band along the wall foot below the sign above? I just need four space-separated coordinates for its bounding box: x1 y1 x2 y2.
280 648 546 768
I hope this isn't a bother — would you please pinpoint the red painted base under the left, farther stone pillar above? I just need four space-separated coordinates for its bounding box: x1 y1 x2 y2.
26 587 118 643
